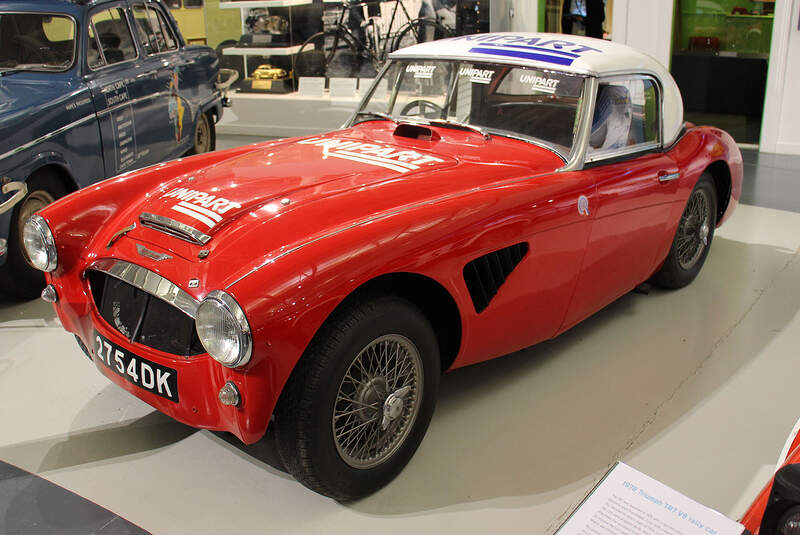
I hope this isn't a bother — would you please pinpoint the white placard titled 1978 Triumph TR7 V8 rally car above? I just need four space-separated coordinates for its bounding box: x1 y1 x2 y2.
556 463 744 535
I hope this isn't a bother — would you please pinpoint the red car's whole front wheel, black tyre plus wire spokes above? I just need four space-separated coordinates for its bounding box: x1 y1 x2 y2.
275 295 440 501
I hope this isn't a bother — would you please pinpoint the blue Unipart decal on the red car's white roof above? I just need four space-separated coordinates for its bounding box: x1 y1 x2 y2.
452 34 602 65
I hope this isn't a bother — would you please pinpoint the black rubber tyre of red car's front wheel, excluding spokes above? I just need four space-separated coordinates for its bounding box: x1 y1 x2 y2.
275 294 441 502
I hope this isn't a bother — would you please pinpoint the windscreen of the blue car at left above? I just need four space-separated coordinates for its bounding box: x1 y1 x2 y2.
0 11 75 72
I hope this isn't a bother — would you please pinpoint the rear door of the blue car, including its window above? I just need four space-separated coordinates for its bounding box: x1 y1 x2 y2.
131 1 193 161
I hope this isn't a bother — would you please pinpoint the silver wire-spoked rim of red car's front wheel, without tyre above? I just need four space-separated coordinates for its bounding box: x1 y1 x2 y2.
332 334 423 469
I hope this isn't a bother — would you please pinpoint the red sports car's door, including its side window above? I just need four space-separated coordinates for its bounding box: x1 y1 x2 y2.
562 75 679 330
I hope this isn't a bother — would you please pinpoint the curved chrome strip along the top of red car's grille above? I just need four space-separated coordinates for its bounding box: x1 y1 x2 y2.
84 258 200 319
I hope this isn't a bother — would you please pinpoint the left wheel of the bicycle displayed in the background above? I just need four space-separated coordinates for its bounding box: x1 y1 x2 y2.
295 30 361 78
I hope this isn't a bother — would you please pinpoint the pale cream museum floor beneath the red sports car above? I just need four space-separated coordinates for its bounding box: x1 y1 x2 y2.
0 144 800 535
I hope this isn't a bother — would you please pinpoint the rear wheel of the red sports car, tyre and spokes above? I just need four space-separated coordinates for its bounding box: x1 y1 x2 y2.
652 171 717 289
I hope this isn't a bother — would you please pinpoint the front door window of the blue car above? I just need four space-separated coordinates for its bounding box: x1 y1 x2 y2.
86 7 136 69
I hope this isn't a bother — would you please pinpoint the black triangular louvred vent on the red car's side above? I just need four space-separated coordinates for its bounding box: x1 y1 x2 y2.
464 243 528 313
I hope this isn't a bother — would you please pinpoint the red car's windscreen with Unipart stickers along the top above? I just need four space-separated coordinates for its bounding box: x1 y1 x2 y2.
357 59 586 156
